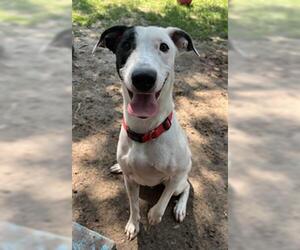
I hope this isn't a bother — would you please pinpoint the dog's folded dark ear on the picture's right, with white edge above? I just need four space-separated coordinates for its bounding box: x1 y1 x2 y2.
167 27 200 56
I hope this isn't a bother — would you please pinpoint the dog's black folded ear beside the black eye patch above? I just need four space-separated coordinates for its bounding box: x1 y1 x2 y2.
92 25 128 54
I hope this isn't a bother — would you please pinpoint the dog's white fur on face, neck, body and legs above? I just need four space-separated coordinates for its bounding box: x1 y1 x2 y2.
114 27 191 239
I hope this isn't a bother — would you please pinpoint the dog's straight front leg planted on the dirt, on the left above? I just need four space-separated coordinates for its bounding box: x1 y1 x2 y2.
124 175 140 240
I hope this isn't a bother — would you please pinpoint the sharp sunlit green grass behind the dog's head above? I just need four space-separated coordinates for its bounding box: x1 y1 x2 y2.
72 0 227 39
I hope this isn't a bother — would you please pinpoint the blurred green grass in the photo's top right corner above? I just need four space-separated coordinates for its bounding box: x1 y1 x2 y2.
229 0 300 39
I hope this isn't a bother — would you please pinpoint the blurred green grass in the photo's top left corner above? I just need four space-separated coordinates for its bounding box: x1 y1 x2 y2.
0 0 72 26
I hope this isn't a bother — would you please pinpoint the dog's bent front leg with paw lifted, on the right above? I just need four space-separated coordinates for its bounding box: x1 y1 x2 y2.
148 175 186 225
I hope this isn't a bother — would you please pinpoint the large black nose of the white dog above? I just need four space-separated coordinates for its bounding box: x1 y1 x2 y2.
131 69 156 92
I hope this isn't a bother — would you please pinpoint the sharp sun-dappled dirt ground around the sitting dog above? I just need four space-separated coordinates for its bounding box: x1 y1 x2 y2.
73 27 228 250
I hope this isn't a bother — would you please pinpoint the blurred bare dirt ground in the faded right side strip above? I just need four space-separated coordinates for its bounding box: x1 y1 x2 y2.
228 35 300 250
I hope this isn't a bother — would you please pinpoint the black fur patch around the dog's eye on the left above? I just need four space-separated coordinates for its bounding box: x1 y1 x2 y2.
115 27 136 78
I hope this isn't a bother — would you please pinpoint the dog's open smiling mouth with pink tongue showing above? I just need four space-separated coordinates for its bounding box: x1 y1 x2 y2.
127 75 169 119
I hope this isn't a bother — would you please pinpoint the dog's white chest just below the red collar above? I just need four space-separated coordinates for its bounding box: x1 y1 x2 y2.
117 127 190 186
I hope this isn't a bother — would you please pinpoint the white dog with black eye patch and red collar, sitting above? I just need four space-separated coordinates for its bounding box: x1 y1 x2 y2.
93 26 199 240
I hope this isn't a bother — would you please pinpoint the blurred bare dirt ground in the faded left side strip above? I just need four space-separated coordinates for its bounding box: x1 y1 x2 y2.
0 23 72 237
